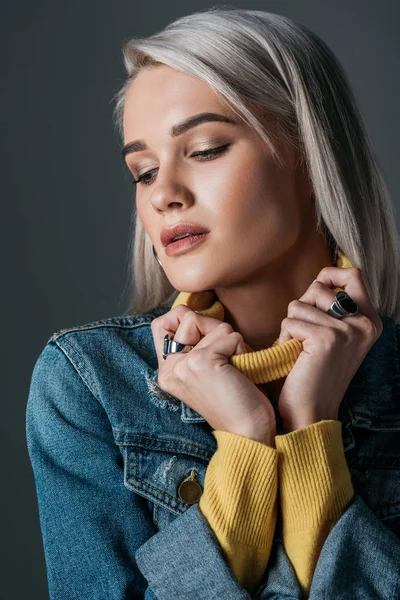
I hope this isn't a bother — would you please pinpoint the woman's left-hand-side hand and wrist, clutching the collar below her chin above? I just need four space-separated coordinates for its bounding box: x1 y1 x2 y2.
151 304 276 447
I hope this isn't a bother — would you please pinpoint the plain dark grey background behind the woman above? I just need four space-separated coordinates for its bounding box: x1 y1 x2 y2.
0 0 400 600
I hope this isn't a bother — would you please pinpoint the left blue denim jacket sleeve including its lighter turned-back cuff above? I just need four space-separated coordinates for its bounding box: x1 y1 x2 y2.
26 341 250 600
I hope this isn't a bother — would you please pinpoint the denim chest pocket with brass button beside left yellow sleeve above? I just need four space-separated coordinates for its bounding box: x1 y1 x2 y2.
123 440 212 530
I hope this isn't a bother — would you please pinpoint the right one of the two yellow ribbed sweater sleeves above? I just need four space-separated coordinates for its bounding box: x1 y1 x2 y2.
275 420 354 598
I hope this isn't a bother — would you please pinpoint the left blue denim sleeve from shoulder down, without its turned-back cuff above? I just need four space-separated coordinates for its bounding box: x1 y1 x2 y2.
26 342 155 600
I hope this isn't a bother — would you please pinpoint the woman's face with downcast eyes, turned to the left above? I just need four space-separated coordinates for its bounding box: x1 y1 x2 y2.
123 65 312 292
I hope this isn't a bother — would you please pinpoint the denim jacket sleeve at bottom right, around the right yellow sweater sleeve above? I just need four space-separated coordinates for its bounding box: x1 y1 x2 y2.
254 494 400 600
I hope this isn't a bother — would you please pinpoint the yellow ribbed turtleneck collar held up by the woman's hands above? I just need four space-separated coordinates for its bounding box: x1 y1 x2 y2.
171 250 353 384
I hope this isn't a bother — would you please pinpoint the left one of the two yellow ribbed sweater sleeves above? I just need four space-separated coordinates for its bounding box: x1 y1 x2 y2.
199 430 278 593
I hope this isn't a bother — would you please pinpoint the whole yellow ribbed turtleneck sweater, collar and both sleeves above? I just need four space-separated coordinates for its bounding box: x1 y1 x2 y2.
171 251 354 598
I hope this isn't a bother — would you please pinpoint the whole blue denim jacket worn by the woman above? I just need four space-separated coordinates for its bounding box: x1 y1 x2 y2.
26 308 400 600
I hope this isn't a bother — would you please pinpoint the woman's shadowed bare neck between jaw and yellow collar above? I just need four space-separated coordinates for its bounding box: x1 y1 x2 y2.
214 234 335 350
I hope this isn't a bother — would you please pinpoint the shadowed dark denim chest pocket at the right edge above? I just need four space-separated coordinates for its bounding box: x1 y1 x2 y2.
346 426 400 537
